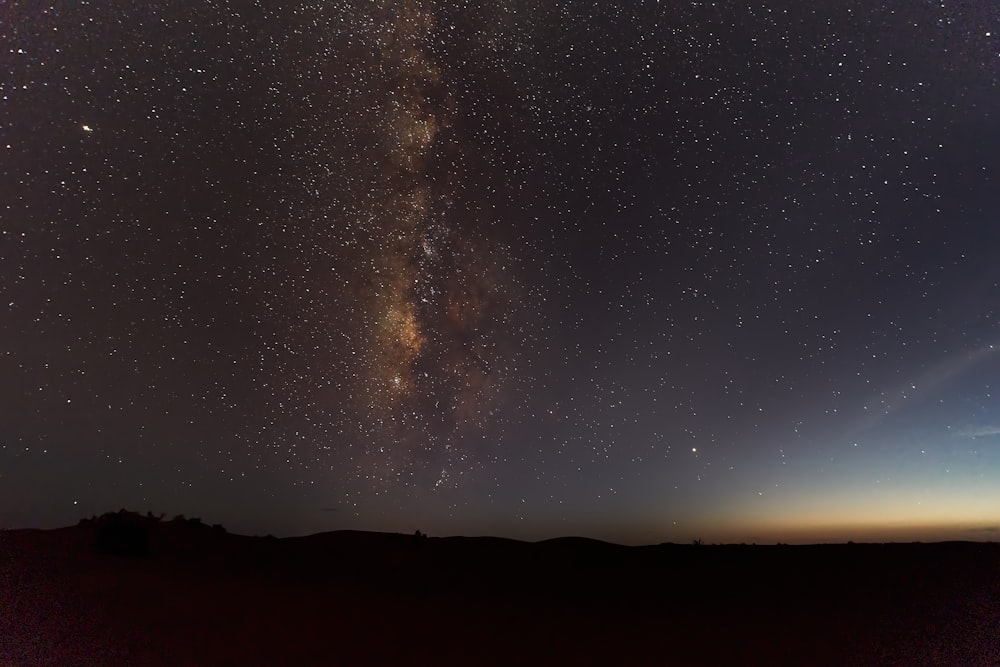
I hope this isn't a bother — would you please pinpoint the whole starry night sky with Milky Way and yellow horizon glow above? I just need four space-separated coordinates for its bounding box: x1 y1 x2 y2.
0 0 1000 543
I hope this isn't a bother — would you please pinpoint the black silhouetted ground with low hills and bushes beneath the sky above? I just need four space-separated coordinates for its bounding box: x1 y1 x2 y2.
0 522 1000 667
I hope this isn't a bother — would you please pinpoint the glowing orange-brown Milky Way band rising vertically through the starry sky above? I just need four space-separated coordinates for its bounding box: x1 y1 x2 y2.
320 2 528 484
